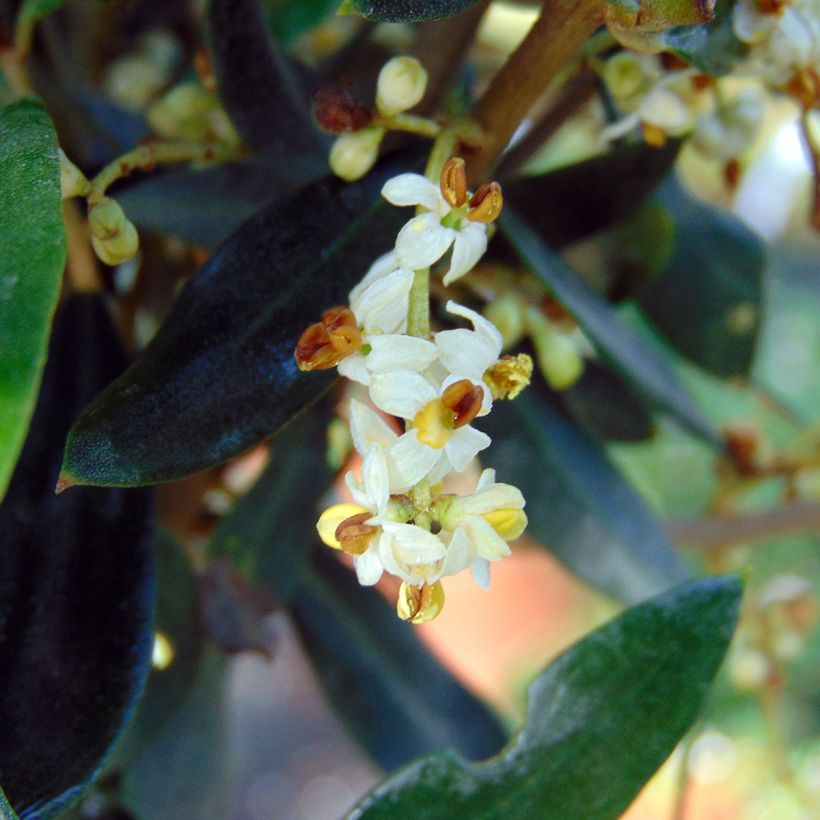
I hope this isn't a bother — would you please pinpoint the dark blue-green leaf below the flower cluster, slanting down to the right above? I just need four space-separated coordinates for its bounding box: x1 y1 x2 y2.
290 549 506 771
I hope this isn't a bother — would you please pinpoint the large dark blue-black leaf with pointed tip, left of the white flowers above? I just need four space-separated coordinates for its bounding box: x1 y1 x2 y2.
64 152 414 486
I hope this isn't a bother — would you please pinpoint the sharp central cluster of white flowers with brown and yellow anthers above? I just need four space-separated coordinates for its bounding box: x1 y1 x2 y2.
295 159 531 623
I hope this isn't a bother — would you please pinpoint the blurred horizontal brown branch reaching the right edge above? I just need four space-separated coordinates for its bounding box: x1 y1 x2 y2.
666 501 820 550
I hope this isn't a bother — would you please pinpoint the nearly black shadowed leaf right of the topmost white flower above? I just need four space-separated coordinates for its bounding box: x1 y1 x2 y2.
504 141 680 248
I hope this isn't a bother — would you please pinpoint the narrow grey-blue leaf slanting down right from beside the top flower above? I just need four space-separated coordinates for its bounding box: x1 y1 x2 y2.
500 207 720 446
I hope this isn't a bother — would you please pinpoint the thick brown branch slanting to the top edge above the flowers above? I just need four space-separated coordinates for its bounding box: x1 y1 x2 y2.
467 0 603 184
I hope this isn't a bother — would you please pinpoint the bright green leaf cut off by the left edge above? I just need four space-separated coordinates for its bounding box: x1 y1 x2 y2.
0 99 66 498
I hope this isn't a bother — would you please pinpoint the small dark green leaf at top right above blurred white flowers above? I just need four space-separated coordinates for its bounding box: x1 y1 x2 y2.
662 0 749 76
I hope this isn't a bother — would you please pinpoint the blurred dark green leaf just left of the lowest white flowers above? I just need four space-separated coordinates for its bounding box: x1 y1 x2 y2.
208 409 332 600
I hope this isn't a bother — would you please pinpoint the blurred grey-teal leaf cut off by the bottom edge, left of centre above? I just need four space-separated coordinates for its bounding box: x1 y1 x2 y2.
118 648 231 820
